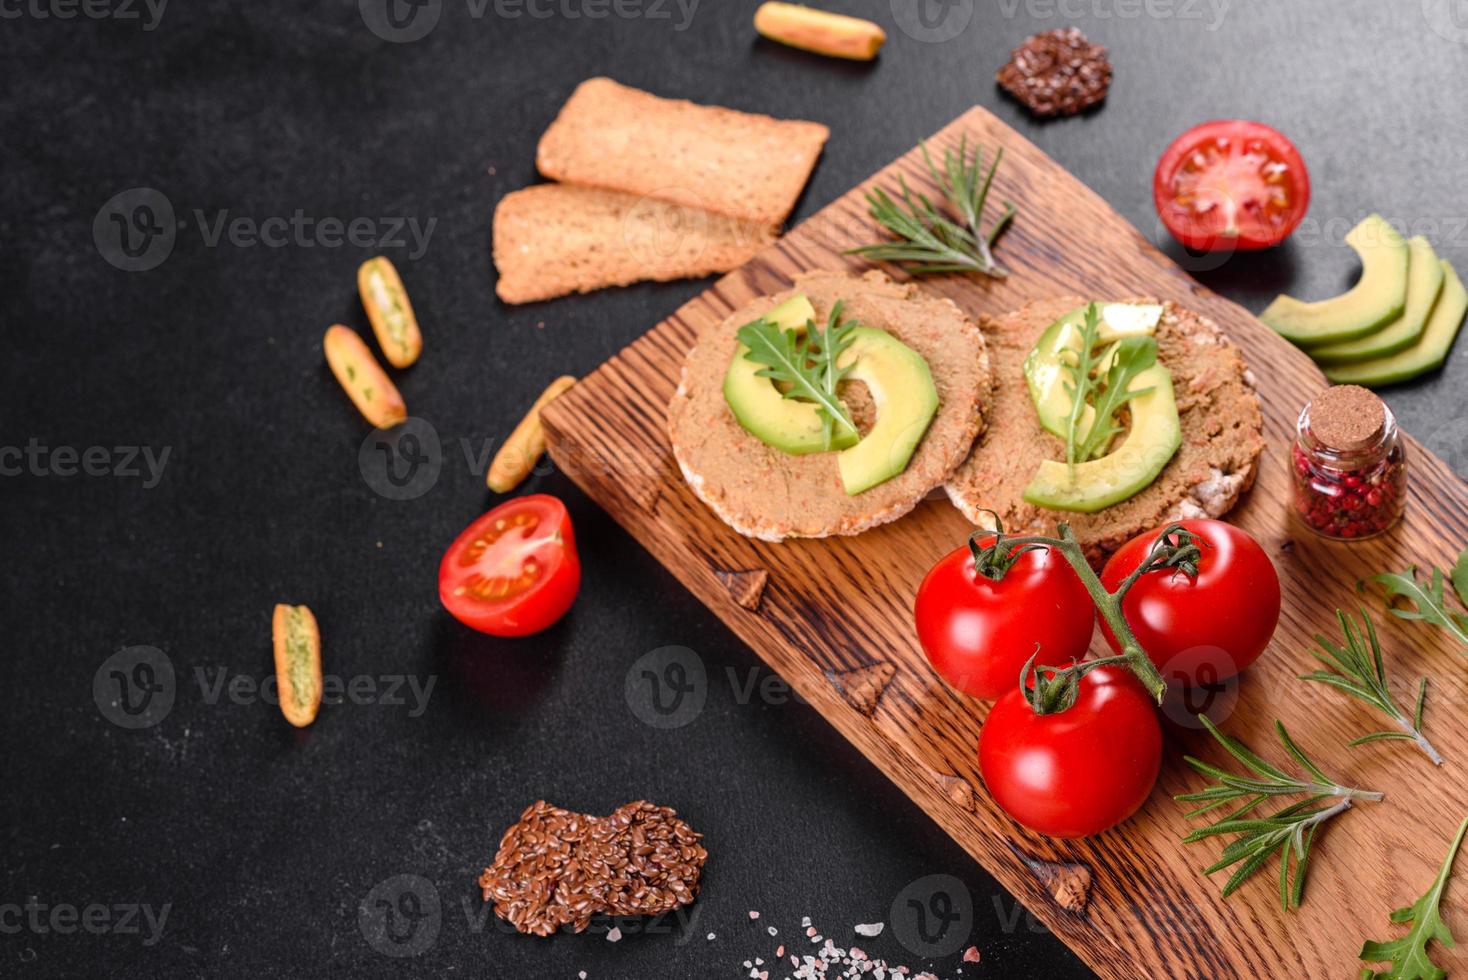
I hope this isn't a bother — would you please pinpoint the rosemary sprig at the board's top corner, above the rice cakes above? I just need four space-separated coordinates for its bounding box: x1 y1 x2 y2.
846 135 1014 279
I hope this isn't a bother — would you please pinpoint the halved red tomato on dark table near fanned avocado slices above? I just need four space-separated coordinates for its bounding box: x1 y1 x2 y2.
1152 119 1309 252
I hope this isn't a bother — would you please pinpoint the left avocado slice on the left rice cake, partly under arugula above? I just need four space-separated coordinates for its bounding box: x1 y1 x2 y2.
724 293 857 456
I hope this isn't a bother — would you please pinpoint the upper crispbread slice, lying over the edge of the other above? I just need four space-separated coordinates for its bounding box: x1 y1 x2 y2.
536 78 831 226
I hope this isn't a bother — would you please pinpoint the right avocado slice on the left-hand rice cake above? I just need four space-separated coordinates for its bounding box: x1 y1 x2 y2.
837 327 938 496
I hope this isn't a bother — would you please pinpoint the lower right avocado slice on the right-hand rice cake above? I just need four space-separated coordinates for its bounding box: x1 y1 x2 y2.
1025 364 1183 513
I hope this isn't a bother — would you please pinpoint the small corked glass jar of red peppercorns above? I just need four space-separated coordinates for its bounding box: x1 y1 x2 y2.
1293 384 1406 540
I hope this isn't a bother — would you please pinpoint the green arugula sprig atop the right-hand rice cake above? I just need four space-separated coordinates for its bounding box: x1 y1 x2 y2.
1061 302 1157 480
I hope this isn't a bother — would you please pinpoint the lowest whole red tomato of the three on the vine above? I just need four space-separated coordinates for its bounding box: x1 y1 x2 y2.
979 666 1163 838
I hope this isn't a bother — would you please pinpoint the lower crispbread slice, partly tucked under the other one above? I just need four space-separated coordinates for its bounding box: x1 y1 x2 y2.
495 183 774 302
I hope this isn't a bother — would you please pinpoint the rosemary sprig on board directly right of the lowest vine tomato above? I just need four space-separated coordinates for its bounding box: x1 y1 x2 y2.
1177 714 1383 911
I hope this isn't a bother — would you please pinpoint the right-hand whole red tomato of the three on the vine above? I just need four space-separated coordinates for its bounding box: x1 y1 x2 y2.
1101 519 1280 685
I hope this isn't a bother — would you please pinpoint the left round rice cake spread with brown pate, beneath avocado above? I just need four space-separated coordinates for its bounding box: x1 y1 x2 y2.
668 271 989 541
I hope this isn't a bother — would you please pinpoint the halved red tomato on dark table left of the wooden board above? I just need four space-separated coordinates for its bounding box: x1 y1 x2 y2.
439 493 581 637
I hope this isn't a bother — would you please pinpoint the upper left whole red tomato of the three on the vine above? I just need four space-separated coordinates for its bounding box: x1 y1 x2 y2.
913 535 1095 700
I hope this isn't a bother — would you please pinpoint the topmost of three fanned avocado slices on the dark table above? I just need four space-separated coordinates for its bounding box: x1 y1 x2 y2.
1260 214 1408 348
